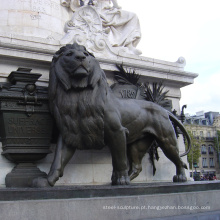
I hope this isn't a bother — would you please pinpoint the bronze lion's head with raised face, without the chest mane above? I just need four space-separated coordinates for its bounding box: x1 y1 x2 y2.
51 43 102 91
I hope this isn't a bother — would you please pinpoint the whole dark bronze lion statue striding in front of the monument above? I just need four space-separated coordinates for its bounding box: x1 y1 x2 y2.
34 44 190 186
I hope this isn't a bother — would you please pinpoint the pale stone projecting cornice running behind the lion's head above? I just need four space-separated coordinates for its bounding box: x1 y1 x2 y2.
0 38 198 88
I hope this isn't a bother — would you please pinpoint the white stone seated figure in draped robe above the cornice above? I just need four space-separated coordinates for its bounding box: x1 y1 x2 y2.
61 0 141 55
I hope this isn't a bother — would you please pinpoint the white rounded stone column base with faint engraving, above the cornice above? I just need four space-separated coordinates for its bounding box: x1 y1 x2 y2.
0 0 70 40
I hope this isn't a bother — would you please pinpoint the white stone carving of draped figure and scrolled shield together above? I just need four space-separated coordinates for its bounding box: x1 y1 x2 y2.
61 0 141 55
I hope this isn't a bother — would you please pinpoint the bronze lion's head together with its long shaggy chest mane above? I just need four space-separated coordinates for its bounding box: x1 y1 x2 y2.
49 44 108 150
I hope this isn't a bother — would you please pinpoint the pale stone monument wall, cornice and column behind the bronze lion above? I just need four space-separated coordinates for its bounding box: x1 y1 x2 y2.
0 0 197 186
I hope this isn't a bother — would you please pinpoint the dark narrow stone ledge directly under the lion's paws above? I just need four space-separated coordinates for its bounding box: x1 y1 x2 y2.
0 181 220 201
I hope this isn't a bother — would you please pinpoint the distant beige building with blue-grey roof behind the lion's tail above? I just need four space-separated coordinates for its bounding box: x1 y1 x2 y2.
185 112 220 178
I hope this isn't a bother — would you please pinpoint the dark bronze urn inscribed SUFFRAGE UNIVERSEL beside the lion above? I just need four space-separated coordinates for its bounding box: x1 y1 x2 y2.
0 68 53 187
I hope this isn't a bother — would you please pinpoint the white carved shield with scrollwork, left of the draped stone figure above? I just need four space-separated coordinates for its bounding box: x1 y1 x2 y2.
60 5 129 56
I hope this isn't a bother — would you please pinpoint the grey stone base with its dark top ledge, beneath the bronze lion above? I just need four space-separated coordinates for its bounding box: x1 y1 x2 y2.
0 181 220 220
